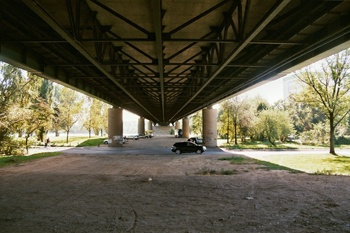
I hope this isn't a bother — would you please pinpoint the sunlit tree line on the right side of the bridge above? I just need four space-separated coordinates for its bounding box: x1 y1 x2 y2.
191 49 350 154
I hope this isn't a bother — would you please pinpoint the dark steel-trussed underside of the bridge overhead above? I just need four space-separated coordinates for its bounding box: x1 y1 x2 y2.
0 0 350 123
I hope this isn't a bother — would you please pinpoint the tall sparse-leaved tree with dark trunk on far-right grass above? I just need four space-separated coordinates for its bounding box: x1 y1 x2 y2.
296 49 350 155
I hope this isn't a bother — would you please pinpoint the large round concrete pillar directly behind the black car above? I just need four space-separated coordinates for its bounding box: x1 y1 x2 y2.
202 106 218 147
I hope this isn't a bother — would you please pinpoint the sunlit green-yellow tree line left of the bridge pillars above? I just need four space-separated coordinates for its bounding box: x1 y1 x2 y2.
0 63 109 155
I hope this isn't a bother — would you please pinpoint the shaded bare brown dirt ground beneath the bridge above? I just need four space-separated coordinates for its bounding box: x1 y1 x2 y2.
0 138 350 233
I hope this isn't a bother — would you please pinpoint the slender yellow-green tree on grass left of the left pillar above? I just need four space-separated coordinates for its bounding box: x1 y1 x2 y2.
58 87 82 143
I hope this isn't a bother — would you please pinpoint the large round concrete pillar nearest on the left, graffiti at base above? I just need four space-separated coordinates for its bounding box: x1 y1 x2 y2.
108 107 123 147
